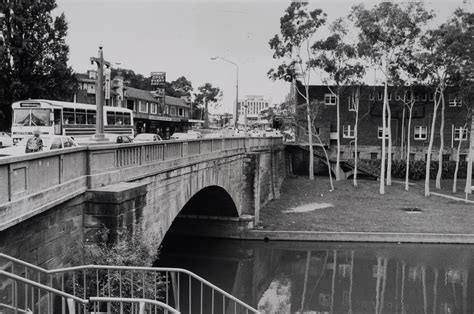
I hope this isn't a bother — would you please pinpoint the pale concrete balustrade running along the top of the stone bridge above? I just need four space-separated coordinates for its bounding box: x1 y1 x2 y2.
0 137 282 230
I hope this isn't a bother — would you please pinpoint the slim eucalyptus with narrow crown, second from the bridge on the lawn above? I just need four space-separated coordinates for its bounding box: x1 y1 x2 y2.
312 18 365 181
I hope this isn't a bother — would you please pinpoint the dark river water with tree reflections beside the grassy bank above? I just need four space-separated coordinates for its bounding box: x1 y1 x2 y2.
156 236 474 314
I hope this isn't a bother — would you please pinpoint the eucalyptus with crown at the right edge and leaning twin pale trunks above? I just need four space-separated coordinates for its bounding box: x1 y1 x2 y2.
419 10 473 196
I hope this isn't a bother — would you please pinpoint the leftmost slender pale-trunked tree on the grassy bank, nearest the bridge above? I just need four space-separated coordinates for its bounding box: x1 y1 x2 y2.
268 2 326 180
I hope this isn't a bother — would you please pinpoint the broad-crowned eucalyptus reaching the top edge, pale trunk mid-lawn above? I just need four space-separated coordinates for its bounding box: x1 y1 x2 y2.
351 2 432 194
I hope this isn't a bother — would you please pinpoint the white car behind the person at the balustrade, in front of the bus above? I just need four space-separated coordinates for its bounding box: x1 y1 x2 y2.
0 135 79 157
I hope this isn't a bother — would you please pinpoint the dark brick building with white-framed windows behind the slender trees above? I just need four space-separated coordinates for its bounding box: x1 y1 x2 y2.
293 82 470 161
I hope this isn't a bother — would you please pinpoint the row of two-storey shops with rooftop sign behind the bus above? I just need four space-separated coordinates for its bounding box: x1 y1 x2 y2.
74 70 191 139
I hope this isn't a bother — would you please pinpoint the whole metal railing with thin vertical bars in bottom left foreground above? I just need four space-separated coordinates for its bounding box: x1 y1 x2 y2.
0 253 259 314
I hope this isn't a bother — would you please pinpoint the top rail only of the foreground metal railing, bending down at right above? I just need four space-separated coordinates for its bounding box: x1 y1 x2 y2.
0 253 260 314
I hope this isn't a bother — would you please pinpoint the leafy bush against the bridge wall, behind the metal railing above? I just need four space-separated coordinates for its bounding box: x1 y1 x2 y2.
68 225 166 313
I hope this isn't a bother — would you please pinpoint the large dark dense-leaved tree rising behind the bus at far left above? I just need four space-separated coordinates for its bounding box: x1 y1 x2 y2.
0 0 76 126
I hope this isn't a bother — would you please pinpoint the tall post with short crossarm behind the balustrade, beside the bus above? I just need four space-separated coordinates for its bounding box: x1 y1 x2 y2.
90 46 110 142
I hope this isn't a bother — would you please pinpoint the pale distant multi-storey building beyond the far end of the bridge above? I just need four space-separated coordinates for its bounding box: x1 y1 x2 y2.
237 95 270 126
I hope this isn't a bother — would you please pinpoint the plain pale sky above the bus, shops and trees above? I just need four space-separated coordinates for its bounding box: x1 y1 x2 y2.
56 0 473 112
